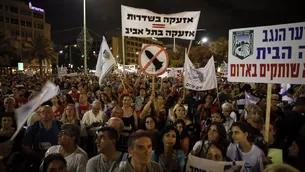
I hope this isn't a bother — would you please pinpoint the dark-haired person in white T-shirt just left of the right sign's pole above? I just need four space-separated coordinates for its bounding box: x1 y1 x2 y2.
227 122 264 172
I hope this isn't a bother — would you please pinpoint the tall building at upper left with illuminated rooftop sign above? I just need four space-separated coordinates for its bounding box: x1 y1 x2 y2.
0 0 51 72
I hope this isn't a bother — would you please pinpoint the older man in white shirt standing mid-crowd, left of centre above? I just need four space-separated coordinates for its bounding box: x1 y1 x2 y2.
82 100 106 127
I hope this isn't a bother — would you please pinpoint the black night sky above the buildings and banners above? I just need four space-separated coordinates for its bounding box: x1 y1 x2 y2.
27 0 305 44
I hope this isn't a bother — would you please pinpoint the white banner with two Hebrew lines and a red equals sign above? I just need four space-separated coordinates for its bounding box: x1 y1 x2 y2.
121 5 200 40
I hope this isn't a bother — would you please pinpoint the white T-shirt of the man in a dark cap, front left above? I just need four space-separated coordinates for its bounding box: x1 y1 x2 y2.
45 145 91 172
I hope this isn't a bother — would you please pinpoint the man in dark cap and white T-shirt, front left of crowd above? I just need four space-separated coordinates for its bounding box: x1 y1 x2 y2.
45 124 88 172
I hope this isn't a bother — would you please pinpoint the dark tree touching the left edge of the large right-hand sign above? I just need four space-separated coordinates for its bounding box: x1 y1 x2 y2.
209 37 228 63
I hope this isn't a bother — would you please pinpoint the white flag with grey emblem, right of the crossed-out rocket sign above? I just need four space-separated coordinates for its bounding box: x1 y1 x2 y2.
184 51 217 91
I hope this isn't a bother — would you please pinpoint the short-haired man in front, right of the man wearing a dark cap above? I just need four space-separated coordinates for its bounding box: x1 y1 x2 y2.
86 127 128 172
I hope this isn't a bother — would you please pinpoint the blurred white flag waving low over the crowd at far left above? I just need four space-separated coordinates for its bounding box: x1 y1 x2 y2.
11 81 60 140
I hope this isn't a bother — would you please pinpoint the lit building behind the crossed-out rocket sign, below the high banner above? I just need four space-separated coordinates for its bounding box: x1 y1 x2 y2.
112 37 163 65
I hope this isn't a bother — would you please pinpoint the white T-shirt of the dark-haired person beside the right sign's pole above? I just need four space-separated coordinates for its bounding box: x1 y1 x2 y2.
227 143 264 172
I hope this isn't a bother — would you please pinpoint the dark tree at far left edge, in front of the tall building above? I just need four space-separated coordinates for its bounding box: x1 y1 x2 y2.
0 33 18 64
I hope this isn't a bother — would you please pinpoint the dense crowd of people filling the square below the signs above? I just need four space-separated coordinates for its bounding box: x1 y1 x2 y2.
0 73 305 172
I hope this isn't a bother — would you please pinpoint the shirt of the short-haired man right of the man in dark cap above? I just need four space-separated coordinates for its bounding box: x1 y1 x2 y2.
86 152 129 172
